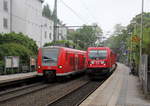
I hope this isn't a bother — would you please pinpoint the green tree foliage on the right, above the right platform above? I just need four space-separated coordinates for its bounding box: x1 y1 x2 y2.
105 12 150 64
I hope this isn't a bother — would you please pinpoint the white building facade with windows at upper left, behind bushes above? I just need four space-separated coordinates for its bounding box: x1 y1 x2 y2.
0 0 67 47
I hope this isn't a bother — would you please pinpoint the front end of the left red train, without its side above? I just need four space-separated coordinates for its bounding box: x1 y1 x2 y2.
37 47 62 81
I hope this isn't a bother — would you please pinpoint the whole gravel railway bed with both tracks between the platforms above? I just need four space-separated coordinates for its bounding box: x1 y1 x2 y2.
0 76 108 106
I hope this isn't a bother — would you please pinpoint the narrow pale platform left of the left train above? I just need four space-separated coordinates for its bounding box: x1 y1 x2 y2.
0 72 37 84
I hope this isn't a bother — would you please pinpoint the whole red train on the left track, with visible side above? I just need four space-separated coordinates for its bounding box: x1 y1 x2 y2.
37 46 87 81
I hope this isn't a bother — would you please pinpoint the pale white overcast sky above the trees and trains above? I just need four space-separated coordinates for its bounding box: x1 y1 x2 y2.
44 0 150 33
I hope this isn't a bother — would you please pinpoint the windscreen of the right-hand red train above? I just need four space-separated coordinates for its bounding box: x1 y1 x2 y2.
89 50 107 59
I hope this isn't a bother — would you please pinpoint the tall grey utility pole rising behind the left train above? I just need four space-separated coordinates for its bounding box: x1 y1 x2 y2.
53 0 57 42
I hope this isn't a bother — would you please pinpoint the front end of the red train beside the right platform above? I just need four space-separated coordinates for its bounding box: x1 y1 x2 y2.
87 47 110 76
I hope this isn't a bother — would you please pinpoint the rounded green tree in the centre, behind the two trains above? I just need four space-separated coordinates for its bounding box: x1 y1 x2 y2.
67 25 102 49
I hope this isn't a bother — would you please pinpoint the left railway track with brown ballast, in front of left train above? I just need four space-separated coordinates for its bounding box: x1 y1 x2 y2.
0 77 88 106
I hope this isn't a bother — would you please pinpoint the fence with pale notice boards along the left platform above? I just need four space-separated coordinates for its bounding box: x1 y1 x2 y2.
0 56 36 75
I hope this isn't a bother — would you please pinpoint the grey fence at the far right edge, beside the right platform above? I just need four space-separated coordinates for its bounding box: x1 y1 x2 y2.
139 54 150 94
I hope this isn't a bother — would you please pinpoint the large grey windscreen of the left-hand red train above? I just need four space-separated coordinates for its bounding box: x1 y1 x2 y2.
42 48 59 66
